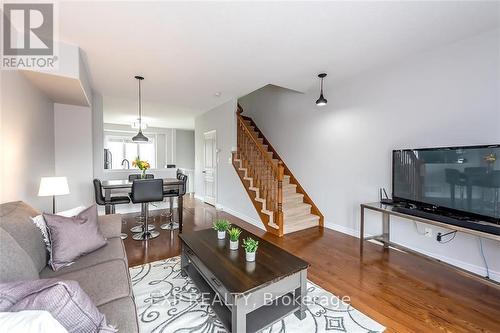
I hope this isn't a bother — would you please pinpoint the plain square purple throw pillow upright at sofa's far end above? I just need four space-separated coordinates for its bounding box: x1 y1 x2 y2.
43 205 106 271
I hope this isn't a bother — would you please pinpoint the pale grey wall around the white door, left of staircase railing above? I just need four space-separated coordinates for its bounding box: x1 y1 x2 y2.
194 100 263 223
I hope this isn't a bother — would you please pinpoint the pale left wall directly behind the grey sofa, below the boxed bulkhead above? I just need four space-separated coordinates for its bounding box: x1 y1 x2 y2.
0 71 55 211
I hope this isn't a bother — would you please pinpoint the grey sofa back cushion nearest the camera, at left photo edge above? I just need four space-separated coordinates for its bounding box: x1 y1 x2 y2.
0 228 38 283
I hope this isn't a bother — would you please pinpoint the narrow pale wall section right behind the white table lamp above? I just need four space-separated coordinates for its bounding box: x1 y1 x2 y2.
54 104 94 210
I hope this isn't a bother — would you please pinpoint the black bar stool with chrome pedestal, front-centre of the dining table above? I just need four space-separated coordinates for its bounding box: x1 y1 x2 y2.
130 179 163 240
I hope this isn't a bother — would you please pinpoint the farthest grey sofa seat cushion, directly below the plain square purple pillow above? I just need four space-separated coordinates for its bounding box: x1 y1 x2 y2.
40 238 127 278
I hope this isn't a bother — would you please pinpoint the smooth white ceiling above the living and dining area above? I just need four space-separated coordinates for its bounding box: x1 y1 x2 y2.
59 1 500 128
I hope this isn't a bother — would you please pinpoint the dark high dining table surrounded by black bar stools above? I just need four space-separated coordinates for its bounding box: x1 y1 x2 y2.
101 178 186 232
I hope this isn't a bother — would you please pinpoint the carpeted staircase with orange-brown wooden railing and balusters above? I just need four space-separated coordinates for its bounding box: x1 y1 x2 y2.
232 105 323 237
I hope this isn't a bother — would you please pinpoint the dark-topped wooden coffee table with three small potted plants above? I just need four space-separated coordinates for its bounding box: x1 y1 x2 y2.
179 229 309 333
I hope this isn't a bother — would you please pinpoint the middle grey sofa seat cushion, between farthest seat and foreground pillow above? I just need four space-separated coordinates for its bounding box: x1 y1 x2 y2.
39 260 132 306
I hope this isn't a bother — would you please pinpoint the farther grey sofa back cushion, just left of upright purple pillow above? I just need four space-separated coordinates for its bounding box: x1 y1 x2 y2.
0 201 47 272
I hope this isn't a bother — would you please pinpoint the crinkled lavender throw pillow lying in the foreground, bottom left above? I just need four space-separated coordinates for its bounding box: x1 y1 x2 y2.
0 279 117 333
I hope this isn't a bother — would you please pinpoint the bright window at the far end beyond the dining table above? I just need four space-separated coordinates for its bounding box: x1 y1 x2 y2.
104 132 156 169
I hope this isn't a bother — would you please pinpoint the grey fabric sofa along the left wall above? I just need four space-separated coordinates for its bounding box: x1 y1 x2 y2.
0 201 139 333
